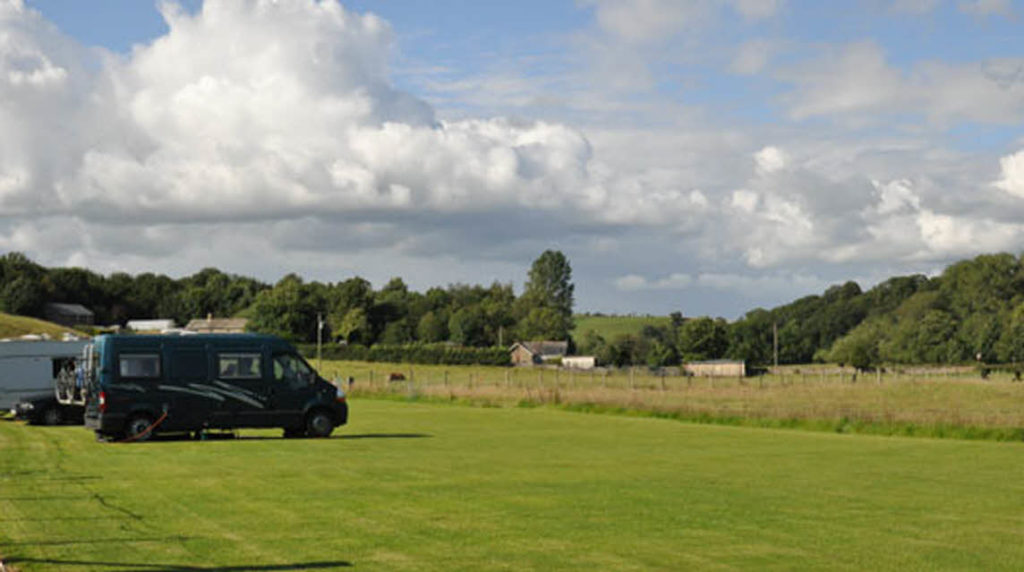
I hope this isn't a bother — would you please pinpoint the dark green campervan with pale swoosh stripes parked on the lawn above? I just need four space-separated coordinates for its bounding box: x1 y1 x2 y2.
79 334 348 440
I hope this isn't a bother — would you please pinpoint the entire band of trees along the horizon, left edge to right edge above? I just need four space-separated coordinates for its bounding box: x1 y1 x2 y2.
0 251 1024 368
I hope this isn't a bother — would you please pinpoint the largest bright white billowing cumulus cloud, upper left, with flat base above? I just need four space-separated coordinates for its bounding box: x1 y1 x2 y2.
0 1 630 220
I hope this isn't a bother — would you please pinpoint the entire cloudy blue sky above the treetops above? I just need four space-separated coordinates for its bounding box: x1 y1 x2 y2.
0 0 1024 319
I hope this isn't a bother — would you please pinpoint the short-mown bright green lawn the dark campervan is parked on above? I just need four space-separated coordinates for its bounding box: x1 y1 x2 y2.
0 399 1024 571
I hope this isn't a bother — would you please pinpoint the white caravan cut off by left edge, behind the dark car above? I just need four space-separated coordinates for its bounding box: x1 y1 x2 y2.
0 341 87 410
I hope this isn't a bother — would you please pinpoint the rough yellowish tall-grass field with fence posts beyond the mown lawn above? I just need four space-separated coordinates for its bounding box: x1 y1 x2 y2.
323 361 1024 441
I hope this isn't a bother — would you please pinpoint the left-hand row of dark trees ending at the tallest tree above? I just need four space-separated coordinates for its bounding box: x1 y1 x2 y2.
0 251 574 347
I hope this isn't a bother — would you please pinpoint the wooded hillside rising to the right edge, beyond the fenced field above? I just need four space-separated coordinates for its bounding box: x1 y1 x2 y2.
578 254 1024 368
